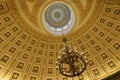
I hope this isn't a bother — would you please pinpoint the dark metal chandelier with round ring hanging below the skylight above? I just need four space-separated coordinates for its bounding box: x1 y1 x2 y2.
57 35 87 77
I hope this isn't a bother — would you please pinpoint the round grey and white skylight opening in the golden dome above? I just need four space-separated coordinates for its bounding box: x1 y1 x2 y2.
43 2 74 35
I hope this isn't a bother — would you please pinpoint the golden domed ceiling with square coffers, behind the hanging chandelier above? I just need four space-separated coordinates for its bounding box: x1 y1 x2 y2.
0 0 120 80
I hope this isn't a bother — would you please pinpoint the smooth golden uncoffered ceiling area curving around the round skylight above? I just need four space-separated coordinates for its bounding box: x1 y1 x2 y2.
5 0 99 38
